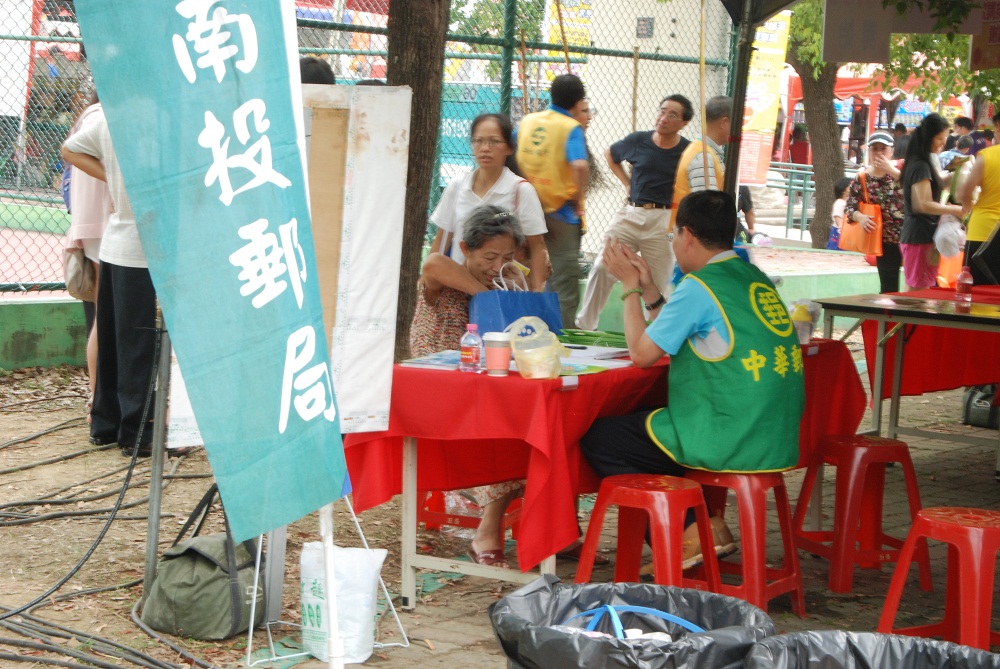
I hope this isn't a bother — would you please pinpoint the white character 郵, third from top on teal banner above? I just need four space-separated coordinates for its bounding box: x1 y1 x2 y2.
229 218 306 309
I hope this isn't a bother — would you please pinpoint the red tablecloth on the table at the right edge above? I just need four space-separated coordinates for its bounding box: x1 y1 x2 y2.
861 286 1000 399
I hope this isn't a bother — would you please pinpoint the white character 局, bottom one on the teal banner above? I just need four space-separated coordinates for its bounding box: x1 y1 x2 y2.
278 325 337 434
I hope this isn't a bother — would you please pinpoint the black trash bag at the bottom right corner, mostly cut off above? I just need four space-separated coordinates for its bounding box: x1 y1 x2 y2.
746 630 1000 669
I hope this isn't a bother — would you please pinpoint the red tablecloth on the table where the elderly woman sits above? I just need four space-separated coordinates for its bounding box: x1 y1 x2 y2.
344 340 865 571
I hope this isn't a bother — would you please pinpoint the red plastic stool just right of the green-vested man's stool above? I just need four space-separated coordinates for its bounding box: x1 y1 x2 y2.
795 434 931 592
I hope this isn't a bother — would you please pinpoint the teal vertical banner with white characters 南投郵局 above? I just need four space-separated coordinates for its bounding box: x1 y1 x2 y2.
76 0 346 540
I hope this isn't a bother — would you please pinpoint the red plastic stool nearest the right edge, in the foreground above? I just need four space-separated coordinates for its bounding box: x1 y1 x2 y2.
878 507 1000 650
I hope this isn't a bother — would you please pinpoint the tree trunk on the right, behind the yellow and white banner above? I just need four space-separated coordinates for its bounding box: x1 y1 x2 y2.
786 45 844 249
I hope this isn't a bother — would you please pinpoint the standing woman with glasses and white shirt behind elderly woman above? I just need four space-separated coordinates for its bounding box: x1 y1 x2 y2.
431 114 549 290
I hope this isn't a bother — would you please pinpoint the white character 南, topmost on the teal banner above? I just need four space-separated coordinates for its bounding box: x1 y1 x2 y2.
173 0 257 84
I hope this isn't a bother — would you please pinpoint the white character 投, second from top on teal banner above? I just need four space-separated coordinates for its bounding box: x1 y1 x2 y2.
198 98 292 206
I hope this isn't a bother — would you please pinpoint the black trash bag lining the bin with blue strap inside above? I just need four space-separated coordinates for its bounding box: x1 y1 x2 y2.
489 574 775 669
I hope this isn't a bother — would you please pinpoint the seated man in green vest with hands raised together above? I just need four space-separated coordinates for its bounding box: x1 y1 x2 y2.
580 191 805 566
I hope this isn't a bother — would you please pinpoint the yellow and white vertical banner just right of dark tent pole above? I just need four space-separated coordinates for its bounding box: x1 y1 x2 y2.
739 11 792 184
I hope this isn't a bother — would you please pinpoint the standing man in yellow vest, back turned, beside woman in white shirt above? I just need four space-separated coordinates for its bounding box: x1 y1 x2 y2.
516 74 590 327
